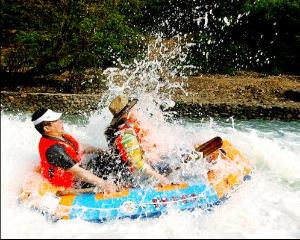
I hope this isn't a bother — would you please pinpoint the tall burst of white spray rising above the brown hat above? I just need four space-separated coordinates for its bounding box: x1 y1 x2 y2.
99 36 193 110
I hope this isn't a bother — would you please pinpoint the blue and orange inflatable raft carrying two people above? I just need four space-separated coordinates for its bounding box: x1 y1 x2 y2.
20 140 251 222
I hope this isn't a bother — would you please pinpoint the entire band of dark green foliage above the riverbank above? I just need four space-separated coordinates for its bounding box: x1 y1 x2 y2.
0 0 300 74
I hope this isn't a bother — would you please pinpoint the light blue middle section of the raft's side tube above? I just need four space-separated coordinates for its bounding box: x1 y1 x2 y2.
69 180 220 222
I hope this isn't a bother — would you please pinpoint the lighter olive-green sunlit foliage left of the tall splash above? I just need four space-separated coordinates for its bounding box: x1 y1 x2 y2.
1 0 145 73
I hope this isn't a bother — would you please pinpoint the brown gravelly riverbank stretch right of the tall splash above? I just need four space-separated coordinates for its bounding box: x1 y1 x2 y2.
170 73 300 120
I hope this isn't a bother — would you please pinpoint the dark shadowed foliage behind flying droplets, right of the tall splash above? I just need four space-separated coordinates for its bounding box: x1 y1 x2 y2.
144 0 300 74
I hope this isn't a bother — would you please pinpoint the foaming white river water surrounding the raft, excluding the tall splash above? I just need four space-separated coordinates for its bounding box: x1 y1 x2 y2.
1 109 300 238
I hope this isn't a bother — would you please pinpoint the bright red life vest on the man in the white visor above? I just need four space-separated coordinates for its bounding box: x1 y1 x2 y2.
39 134 81 188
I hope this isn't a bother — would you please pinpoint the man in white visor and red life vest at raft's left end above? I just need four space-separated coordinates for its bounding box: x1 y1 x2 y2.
31 108 117 193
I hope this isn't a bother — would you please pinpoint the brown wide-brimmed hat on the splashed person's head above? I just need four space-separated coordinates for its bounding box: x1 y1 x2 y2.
108 96 138 125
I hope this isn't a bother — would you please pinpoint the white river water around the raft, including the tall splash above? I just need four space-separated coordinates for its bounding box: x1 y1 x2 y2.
1 35 300 238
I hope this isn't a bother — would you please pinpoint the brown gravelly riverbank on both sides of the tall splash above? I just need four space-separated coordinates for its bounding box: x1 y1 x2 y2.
1 73 300 120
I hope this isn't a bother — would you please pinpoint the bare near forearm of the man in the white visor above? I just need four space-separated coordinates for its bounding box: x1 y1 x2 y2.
69 164 117 193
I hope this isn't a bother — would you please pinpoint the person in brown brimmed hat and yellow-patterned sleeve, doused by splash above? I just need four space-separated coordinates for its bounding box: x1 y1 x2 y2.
105 96 170 184
